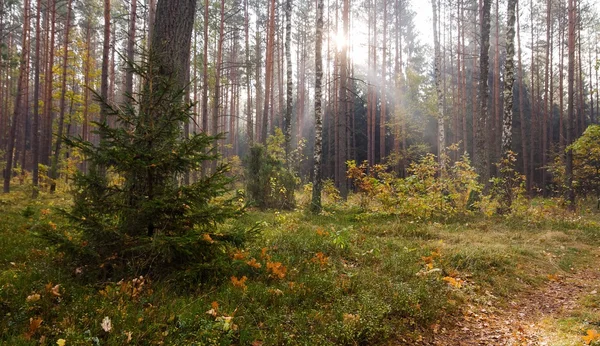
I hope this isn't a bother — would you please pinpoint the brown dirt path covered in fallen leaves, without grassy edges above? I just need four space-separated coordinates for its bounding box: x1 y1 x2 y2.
423 268 600 346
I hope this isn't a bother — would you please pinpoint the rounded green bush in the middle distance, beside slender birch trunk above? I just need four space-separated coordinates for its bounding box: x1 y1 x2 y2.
245 129 297 209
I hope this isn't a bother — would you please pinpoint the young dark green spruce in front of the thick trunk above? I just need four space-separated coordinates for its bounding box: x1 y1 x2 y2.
40 58 251 277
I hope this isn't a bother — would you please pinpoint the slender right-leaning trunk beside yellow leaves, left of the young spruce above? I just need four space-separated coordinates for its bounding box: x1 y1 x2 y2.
50 0 71 192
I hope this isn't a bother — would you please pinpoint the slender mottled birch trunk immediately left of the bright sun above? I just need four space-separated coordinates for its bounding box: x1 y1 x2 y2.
311 0 323 213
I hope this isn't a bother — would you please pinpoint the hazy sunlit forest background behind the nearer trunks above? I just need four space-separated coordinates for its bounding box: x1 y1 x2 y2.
0 0 600 195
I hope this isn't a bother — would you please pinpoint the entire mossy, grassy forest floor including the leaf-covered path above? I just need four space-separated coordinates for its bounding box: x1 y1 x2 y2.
0 188 600 346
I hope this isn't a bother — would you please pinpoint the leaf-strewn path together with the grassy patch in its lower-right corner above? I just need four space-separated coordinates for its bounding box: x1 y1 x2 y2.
421 256 600 346
